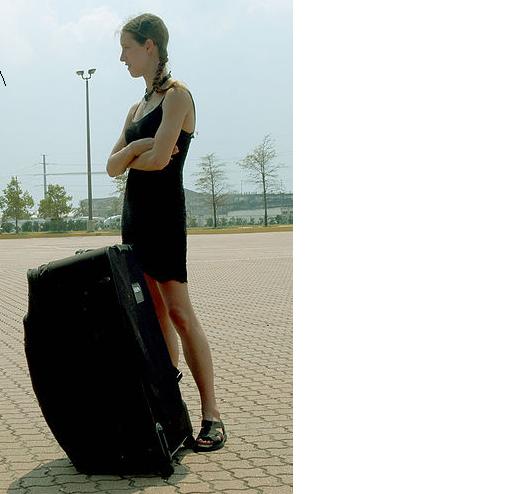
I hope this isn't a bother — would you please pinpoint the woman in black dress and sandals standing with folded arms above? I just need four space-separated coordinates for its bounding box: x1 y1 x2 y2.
107 14 227 451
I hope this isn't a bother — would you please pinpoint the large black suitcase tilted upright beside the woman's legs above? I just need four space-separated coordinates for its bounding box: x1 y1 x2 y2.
23 245 192 476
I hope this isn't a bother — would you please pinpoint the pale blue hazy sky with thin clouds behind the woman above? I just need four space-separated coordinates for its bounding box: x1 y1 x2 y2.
0 0 293 205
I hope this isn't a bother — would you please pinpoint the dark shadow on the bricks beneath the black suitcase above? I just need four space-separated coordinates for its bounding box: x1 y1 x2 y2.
7 449 192 494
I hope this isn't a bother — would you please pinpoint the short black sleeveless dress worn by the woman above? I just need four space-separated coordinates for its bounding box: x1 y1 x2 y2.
121 89 195 283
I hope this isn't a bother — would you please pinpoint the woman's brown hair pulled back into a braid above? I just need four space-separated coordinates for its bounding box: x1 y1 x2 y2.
121 13 169 92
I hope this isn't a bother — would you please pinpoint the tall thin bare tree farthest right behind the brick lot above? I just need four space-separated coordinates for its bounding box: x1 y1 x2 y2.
239 134 281 226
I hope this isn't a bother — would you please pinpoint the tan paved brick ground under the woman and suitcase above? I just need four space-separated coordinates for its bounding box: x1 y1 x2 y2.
0 232 292 494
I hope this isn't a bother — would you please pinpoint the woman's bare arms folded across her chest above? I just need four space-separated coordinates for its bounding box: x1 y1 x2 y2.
107 89 189 177
